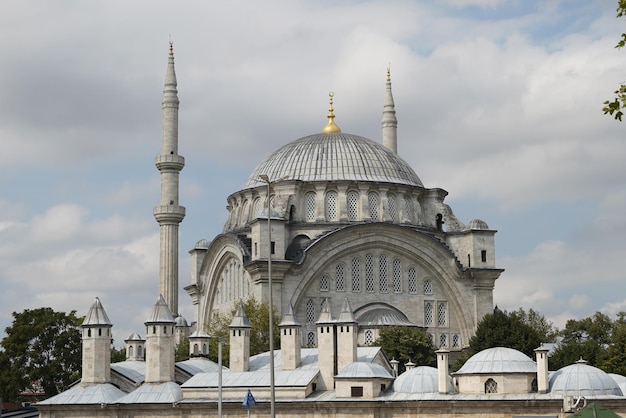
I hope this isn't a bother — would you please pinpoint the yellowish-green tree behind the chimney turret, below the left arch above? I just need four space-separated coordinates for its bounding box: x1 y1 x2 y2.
206 297 280 365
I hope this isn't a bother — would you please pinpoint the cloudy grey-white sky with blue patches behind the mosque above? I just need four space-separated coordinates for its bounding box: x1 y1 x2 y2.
0 0 626 345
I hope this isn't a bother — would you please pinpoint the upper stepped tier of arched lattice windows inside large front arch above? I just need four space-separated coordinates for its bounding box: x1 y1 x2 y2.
319 253 434 295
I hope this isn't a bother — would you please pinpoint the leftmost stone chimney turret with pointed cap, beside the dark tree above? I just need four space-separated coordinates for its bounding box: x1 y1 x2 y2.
81 298 113 383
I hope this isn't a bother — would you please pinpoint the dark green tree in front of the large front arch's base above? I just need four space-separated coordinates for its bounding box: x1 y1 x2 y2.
372 326 436 372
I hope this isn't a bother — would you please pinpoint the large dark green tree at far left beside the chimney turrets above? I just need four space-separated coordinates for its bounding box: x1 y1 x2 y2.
0 308 83 400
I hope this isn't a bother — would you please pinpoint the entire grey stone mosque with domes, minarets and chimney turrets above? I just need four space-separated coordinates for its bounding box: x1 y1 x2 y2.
37 45 626 418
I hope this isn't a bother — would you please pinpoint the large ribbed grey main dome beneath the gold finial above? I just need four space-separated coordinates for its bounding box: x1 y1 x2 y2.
244 133 423 188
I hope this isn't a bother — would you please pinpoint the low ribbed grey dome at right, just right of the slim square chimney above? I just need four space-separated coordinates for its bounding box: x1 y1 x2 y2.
550 360 623 396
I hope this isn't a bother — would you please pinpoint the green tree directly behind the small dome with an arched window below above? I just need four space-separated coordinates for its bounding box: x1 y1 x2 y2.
469 308 556 358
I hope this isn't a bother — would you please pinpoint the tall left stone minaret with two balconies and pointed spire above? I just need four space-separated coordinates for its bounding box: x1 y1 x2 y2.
154 42 185 316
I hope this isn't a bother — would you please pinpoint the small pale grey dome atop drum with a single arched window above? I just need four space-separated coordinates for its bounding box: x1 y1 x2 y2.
454 347 537 374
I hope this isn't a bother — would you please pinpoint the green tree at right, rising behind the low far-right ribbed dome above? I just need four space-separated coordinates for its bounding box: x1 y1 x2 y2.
550 312 613 370
